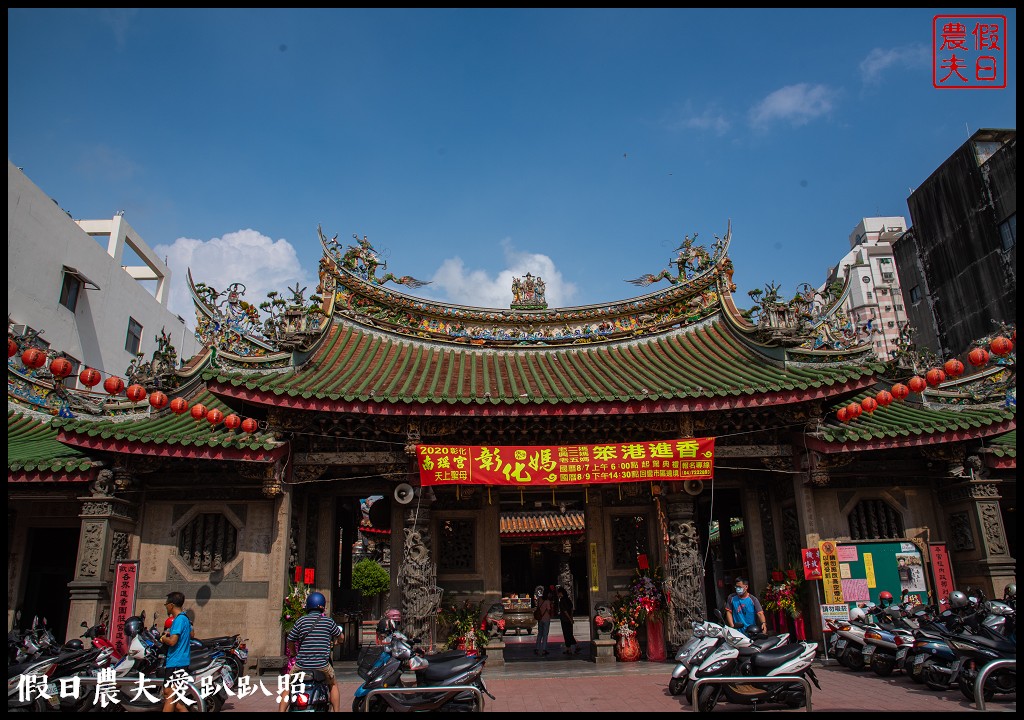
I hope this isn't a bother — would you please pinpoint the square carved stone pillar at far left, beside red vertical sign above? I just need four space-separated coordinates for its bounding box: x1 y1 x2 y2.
68 469 138 636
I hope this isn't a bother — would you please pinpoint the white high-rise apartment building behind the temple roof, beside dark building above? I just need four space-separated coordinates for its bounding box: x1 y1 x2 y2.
820 217 907 361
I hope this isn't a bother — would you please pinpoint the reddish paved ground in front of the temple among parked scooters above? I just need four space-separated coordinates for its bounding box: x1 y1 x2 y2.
224 645 1017 713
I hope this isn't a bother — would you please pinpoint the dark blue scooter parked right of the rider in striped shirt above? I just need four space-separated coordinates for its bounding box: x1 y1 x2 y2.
352 631 495 713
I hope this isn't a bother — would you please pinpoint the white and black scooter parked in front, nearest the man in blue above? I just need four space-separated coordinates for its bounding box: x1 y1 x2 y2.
691 628 821 713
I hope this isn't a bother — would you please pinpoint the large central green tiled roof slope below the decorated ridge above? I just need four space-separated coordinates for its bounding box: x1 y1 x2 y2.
204 322 882 406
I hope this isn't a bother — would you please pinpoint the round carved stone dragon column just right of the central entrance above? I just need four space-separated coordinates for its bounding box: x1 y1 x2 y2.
665 493 708 650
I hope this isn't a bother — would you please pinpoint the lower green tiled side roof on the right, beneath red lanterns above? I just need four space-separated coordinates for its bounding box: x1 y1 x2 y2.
817 389 1017 442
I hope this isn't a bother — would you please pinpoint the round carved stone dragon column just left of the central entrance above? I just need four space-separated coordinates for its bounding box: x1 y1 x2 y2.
398 488 441 645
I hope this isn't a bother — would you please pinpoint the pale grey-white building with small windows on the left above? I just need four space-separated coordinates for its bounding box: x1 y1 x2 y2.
7 160 200 387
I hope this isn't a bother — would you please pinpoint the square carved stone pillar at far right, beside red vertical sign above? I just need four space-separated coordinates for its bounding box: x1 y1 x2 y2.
939 479 1017 597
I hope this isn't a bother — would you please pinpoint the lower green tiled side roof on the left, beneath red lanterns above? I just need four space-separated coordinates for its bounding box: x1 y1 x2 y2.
53 390 282 451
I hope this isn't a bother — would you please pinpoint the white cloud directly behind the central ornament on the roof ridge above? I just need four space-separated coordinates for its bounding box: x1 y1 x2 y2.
423 239 577 308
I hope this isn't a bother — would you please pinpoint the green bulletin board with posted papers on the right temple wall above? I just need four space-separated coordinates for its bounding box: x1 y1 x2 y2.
836 540 929 604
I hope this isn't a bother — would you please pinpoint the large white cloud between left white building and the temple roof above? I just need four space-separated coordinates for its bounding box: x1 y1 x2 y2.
154 229 316 329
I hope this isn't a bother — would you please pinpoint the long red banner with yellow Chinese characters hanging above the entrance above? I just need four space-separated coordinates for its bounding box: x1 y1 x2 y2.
416 437 715 488
